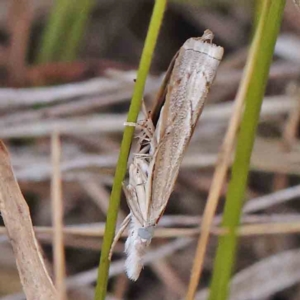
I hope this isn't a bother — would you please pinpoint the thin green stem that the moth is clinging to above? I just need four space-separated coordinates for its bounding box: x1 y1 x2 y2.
95 0 167 300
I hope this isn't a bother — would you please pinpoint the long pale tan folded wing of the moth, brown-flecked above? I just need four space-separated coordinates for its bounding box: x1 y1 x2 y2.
147 39 223 224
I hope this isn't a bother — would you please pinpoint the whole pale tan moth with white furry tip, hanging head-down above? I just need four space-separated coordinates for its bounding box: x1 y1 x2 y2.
111 30 224 280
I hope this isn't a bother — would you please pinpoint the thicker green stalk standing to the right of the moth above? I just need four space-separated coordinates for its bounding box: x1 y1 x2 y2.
209 0 285 300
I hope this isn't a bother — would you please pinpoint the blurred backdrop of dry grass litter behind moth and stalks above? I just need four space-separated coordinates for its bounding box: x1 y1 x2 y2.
0 0 300 300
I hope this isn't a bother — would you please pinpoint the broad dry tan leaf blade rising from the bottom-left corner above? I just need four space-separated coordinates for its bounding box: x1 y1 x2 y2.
0 142 57 300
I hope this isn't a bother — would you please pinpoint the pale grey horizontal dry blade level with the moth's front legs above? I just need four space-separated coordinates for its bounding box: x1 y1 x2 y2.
0 95 295 138
